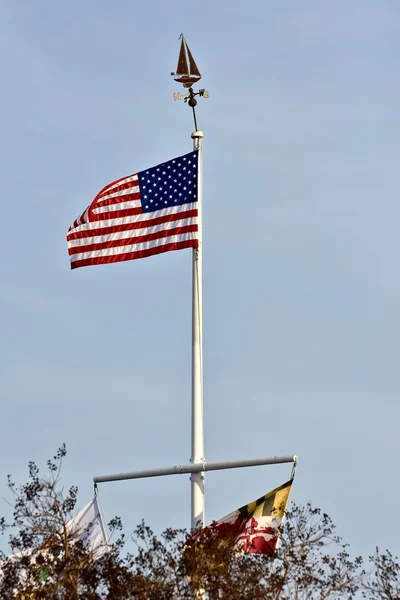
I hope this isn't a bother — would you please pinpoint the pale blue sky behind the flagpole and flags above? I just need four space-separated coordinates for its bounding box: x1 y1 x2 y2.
0 0 400 554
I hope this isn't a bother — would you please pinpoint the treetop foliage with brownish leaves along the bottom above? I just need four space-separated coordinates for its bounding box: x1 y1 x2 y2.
0 445 400 600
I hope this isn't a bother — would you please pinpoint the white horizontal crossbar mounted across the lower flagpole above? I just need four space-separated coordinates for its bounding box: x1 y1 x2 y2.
93 454 297 483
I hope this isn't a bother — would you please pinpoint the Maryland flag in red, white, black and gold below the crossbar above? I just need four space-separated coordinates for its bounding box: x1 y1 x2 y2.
204 479 293 554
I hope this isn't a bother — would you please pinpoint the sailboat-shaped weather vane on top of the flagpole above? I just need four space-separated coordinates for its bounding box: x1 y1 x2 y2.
171 33 210 131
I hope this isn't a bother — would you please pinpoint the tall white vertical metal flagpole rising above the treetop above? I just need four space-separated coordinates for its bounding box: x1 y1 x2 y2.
190 131 205 529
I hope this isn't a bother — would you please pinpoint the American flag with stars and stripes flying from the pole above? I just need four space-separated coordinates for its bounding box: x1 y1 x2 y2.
67 150 198 269
